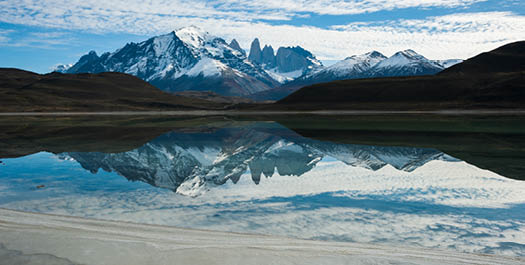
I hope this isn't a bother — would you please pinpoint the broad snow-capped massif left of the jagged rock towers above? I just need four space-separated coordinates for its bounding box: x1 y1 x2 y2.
61 27 277 96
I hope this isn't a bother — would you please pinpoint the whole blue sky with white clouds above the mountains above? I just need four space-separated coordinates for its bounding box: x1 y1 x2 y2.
0 0 525 73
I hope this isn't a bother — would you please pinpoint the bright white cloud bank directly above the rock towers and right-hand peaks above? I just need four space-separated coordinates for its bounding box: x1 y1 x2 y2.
208 12 525 60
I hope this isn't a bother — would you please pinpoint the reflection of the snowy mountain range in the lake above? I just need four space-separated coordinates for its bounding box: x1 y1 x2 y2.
60 123 458 196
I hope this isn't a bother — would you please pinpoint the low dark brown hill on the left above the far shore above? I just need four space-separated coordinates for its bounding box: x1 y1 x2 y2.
0 68 224 112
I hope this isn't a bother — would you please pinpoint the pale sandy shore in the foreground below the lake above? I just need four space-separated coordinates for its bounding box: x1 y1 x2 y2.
0 209 525 265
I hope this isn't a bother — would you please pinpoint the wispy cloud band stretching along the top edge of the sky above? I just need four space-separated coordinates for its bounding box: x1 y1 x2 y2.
0 0 485 27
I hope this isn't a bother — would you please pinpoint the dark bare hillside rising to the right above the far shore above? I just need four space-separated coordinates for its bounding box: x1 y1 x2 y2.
276 42 525 110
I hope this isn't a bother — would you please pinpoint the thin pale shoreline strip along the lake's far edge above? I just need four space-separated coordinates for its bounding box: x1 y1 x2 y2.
0 109 525 116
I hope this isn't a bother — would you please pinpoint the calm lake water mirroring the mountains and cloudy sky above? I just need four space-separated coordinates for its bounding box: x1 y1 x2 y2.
0 117 525 256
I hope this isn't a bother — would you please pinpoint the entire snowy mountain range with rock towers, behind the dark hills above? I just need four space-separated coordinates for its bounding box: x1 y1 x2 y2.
55 26 459 100
